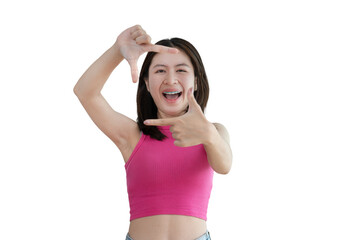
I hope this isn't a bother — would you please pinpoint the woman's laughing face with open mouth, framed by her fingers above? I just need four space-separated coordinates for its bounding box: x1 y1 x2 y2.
145 51 196 118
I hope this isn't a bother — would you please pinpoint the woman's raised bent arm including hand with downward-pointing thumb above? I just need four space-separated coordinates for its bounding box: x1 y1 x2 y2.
74 25 177 161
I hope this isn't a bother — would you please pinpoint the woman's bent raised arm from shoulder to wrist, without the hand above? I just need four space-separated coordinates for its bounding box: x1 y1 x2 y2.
74 43 140 158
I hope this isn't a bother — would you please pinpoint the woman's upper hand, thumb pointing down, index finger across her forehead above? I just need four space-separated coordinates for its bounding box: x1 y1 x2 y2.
116 25 179 83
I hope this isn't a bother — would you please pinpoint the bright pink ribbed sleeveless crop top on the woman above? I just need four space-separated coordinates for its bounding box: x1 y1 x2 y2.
125 126 214 221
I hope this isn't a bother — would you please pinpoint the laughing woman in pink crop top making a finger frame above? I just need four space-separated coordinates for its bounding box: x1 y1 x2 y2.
74 25 232 240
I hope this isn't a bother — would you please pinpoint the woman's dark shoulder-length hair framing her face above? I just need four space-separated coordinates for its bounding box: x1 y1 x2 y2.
136 38 209 141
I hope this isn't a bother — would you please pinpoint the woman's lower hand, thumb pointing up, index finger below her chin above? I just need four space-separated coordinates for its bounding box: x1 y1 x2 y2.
144 88 216 147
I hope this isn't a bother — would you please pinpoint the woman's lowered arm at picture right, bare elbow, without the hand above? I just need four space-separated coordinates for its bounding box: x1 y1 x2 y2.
203 123 232 174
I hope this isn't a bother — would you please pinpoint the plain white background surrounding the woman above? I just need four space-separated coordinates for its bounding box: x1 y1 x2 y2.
0 0 360 240
